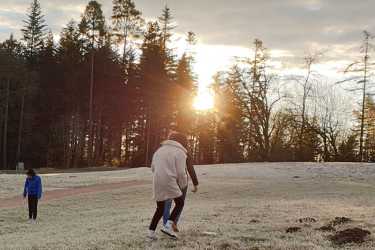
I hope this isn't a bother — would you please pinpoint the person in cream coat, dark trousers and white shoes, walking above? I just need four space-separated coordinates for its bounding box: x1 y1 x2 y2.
148 133 188 240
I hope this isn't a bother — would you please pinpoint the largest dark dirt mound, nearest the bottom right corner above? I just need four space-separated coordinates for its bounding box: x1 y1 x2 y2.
330 227 371 245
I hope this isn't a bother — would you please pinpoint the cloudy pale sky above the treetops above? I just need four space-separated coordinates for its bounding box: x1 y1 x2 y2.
0 0 375 86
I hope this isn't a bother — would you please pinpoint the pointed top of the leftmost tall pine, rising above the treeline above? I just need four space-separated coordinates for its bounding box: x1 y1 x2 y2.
21 0 47 64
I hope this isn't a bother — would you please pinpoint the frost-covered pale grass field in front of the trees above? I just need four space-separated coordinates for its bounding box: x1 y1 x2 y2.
0 163 375 250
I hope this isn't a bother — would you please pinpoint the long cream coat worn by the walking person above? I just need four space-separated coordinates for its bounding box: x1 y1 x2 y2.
151 140 188 201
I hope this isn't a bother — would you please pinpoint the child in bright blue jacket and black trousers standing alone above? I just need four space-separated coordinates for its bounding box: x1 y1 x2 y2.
23 169 42 223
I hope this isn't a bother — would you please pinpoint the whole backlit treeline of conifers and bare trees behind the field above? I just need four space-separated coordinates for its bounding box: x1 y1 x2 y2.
0 0 375 169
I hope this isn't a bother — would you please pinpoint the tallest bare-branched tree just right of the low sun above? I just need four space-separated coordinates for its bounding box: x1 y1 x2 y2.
228 39 282 161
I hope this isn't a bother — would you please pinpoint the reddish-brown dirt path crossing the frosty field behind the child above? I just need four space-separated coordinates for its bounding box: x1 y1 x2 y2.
0 181 150 208
